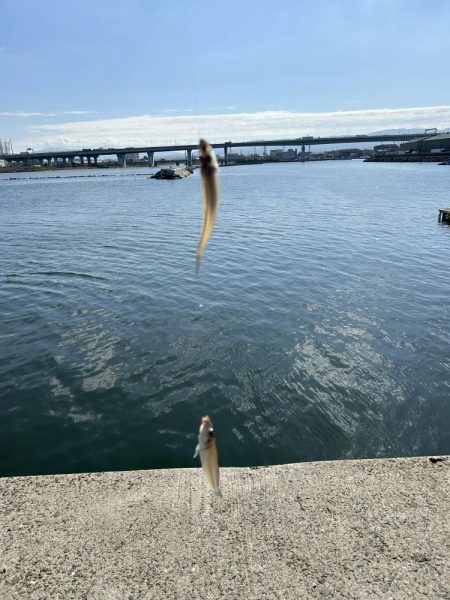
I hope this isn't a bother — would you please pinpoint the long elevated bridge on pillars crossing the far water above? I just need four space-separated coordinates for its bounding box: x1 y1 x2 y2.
0 133 429 167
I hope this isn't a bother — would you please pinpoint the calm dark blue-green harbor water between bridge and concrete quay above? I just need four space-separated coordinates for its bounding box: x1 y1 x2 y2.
0 161 450 476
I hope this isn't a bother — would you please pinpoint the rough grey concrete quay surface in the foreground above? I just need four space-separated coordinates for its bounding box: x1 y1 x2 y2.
0 457 450 600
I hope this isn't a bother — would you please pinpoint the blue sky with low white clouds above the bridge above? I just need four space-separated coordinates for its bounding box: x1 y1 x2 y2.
0 0 450 151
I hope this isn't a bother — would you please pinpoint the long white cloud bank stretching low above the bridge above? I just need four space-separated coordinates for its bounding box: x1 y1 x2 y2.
24 105 450 149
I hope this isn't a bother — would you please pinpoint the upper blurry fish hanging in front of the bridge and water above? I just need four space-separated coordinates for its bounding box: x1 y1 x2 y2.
197 140 219 268
